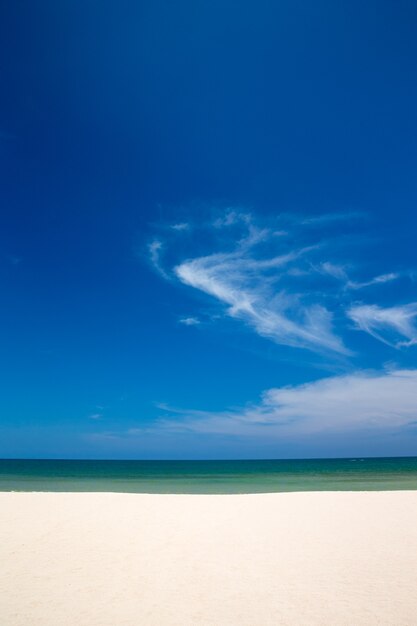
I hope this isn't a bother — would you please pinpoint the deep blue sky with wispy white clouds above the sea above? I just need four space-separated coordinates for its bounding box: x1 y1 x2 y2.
0 0 417 459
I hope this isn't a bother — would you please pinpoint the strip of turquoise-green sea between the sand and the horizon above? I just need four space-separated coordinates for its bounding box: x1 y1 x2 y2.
0 457 417 494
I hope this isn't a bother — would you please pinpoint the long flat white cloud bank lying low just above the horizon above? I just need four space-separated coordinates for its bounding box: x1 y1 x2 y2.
152 370 417 439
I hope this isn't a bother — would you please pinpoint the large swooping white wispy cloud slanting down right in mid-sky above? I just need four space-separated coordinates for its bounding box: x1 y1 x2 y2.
174 232 349 354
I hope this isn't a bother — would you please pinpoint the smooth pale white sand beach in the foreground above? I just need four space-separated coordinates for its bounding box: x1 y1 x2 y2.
0 491 417 626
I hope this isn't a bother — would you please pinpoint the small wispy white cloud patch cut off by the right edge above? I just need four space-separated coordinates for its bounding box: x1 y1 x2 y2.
347 302 417 348
